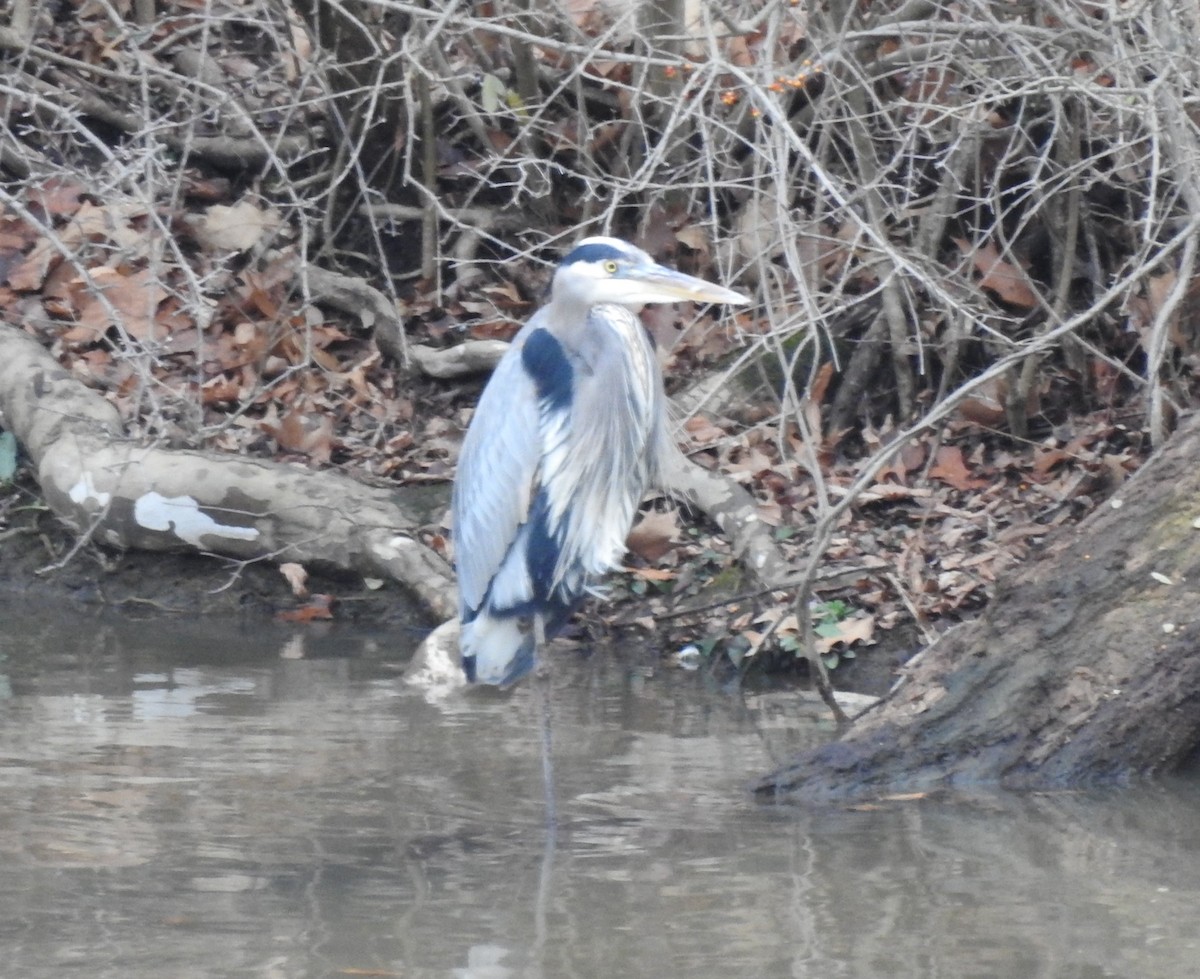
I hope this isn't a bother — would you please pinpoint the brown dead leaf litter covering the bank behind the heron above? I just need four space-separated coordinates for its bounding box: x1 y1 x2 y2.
0 0 1161 691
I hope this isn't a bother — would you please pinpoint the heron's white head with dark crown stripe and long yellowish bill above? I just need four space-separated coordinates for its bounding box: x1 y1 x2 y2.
552 238 750 312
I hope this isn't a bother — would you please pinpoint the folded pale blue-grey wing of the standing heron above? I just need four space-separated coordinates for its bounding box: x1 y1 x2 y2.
452 317 541 613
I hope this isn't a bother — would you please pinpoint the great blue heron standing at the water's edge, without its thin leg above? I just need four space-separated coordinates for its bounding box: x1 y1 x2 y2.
452 238 749 684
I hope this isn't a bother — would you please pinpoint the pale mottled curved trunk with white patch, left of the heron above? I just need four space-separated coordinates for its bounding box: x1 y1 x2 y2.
0 325 455 618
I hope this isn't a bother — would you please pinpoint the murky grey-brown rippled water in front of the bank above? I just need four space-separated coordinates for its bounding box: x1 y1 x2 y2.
0 605 1200 979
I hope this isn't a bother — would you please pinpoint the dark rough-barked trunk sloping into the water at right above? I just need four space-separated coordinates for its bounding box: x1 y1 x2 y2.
757 416 1200 800
